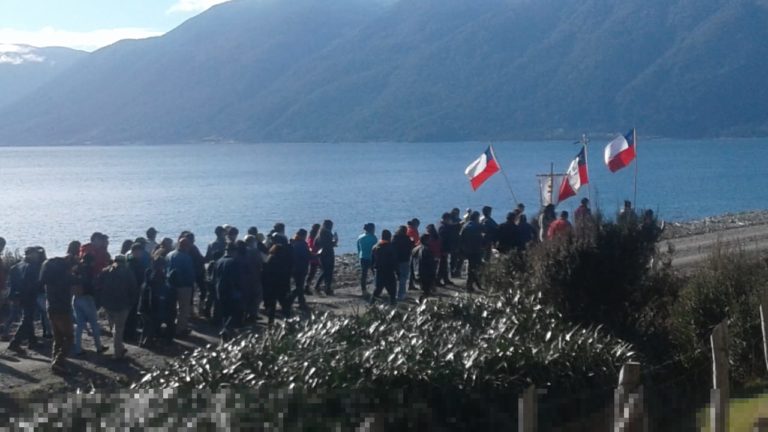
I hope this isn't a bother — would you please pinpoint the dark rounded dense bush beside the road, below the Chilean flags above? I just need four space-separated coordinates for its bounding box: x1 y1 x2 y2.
486 213 680 361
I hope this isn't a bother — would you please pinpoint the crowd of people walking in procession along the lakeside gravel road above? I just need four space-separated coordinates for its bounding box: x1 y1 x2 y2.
0 198 660 373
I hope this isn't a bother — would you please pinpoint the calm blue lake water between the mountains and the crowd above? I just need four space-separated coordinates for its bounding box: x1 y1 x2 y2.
0 137 768 255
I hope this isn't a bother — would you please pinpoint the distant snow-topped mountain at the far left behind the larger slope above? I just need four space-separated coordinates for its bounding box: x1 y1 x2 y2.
0 44 88 107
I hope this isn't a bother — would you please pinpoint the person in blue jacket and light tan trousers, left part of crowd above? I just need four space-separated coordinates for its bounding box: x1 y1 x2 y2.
165 237 195 337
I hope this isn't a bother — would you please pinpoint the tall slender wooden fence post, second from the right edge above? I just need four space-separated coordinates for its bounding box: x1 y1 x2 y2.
710 321 730 432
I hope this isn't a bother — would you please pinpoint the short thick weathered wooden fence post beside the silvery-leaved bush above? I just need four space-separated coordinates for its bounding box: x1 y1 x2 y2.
613 362 646 432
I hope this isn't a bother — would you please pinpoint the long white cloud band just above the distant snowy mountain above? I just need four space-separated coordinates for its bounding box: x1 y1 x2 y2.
0 27 163 51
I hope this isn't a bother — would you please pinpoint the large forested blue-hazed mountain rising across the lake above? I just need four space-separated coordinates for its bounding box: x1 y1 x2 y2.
0 0 768 144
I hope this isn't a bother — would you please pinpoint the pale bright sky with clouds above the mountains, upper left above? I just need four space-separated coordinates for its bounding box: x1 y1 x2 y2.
0 0 227 51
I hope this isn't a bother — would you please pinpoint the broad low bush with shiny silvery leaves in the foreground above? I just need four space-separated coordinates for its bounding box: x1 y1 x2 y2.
117 293 633 430
